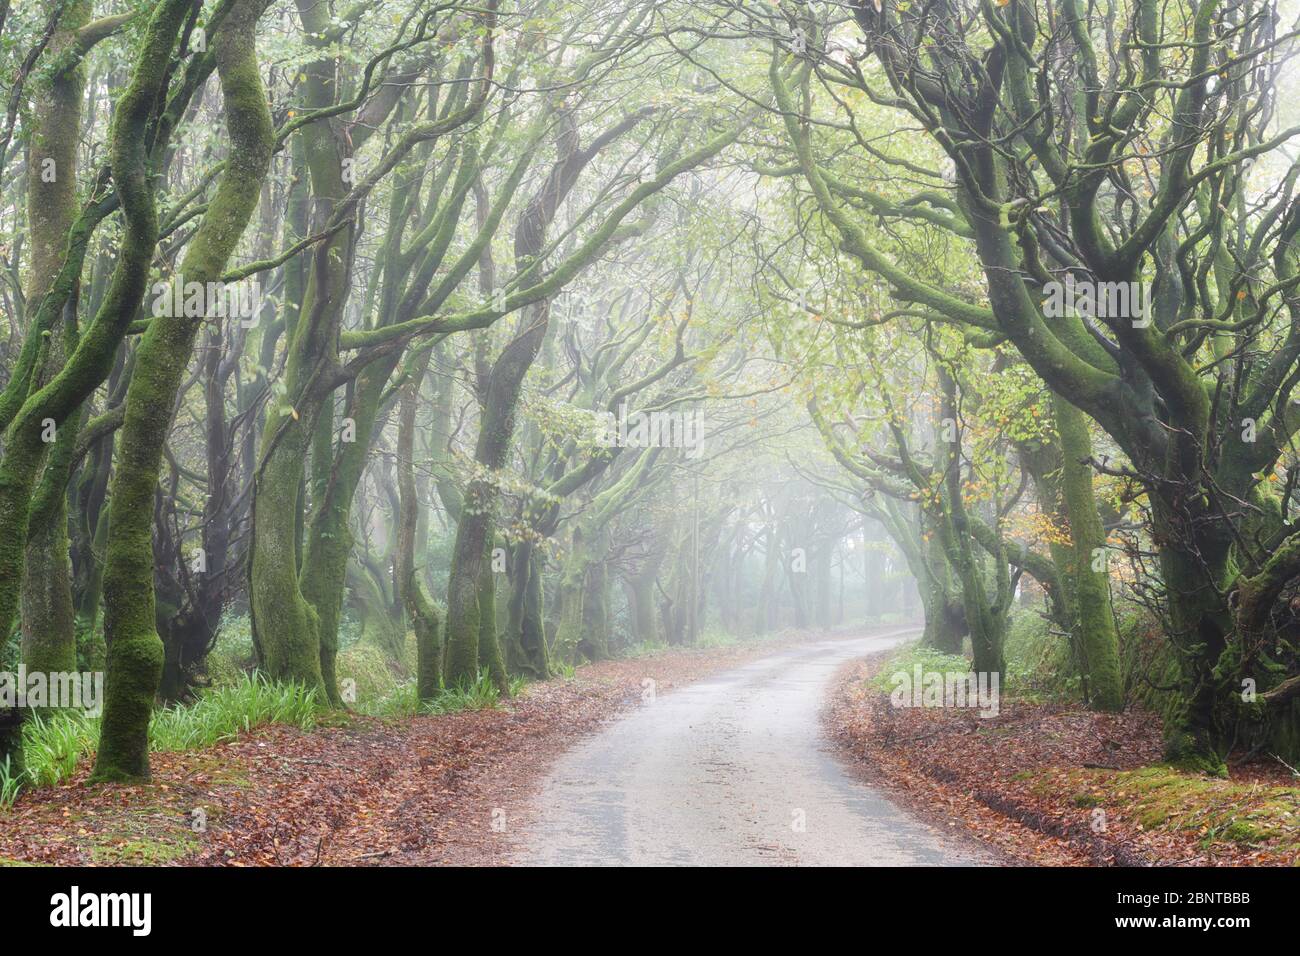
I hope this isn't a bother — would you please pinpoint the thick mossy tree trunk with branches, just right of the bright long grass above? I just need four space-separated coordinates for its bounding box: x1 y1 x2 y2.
251 13 493 704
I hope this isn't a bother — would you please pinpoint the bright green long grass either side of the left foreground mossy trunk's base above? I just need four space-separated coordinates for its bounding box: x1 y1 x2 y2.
0 674 319 806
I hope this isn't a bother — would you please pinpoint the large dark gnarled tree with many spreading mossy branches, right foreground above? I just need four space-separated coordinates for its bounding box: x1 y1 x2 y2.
770 16 1279 770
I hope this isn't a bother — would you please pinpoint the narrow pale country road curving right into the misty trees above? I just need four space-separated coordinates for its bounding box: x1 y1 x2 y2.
514 630 995 866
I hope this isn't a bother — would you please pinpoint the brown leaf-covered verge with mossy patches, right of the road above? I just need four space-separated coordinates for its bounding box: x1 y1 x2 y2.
824 621 1300 866
